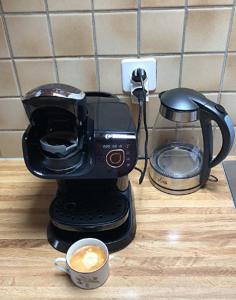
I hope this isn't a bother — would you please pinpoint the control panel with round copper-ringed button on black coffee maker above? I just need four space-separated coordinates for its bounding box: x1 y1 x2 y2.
96 134 137 176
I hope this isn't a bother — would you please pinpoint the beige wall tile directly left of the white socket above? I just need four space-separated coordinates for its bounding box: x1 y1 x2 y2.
99 58 123 94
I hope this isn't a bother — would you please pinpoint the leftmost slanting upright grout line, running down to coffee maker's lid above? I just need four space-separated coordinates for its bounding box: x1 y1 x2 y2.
0 0 23 98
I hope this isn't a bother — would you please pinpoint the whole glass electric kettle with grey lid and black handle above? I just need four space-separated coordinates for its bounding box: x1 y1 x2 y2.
149 88 234 194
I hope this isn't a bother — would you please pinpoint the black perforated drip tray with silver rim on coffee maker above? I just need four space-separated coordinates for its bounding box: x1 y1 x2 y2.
49 192 129 231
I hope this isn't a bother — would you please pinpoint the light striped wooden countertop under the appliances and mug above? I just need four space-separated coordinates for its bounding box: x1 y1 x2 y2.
0 161 236 300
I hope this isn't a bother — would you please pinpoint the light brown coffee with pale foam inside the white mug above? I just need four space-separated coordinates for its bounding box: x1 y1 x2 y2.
70 245 106 273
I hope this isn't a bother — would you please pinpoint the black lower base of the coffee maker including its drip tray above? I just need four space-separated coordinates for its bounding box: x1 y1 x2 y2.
47 180 136 253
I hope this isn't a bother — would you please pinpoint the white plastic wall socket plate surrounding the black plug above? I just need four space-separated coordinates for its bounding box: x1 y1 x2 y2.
121 57 157 92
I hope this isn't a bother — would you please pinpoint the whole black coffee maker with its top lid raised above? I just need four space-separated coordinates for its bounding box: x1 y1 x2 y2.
23 84 137 252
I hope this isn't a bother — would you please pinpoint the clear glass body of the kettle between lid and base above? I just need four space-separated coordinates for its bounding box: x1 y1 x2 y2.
150 112 203 183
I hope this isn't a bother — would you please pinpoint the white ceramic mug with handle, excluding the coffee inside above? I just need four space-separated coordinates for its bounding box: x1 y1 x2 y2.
54 238 109 289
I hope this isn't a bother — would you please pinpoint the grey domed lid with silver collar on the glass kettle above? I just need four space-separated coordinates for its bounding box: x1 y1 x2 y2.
159 88 202 122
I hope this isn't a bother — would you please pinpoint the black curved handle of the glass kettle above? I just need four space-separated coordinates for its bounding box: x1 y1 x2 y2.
200 100 235 168
